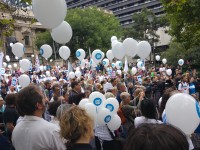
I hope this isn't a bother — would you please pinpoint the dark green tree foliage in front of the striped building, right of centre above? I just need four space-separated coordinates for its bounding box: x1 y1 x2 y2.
125 8 168 42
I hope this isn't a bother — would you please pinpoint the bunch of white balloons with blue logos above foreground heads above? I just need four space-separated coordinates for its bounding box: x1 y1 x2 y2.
79 92 121 131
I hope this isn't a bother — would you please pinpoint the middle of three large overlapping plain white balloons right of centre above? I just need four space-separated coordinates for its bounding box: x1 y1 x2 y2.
123 38 138 57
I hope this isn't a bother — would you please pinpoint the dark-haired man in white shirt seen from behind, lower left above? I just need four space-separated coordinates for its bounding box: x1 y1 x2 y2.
12 85 66 150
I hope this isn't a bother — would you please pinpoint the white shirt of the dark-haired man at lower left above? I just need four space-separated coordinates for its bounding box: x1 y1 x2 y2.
12 116 66 150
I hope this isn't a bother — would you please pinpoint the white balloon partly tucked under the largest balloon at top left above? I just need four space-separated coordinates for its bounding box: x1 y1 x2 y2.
51 21 72 44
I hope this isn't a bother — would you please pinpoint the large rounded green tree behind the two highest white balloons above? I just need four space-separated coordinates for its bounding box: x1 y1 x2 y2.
36 7 123 57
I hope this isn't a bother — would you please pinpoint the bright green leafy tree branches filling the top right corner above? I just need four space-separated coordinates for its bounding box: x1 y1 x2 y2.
161 0 200 50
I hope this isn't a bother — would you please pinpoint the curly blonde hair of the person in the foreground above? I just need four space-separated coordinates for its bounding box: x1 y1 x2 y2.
60 106 93 145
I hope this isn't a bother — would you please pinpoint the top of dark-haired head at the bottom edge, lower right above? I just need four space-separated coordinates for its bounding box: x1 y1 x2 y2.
124 124 189 150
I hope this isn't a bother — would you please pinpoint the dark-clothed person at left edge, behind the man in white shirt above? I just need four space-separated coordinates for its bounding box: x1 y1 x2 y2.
3 94 19 141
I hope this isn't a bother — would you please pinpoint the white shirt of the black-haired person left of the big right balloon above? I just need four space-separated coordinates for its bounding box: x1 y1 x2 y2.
134 116 163 128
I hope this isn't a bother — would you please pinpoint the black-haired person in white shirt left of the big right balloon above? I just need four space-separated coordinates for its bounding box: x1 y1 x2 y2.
134 99 162 128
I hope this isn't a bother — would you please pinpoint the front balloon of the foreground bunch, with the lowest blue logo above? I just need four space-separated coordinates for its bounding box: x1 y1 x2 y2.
96 108 112 126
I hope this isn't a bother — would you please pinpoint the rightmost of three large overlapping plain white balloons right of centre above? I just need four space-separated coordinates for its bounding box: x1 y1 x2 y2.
137 41 151 59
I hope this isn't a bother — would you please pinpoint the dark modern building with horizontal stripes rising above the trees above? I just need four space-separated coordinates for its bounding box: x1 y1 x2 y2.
66 0 164 27
